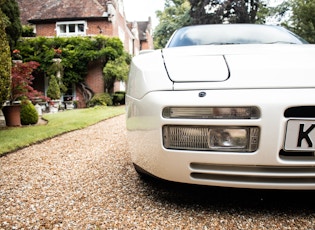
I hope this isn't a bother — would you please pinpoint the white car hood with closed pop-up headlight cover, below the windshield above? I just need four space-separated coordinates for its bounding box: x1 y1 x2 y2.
162 44 315 90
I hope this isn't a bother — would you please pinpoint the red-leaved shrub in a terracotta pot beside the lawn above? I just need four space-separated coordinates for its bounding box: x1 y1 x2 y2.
2 61 46 126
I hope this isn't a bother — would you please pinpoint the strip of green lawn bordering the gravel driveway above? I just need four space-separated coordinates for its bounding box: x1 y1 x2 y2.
0 106 125 156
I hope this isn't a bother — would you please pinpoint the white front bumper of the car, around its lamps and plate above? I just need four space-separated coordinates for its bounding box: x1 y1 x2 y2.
126 89 315 189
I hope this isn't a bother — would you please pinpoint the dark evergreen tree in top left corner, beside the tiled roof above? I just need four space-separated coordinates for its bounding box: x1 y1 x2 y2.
0 0 22 50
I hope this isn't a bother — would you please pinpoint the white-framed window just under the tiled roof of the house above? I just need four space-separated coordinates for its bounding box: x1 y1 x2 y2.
56 21 87 36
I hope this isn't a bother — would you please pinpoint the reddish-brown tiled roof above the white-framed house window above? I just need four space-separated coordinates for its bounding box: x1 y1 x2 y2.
17 0 107 24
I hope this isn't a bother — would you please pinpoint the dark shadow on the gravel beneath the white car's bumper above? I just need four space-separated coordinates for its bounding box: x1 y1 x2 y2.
137 176 315 215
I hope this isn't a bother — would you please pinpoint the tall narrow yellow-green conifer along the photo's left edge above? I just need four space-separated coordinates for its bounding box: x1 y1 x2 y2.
0 4 11 109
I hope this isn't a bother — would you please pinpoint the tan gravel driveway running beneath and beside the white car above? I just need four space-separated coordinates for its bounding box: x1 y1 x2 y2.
0 116 315 229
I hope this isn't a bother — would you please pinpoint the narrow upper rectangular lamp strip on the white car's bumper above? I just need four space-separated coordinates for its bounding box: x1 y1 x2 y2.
162 106 260 119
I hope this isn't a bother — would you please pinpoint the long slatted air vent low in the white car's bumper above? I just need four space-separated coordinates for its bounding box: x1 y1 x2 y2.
190 163 315 185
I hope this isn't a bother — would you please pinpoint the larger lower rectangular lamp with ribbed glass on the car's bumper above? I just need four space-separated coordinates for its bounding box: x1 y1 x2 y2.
163 125 260 152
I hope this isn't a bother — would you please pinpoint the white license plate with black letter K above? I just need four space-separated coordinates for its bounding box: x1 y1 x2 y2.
284 120 315 151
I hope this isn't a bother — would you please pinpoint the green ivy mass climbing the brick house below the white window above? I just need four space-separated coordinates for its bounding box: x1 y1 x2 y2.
17 35 125 86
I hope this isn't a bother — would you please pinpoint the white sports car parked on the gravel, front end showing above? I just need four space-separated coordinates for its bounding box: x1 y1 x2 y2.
126 24 315 189
